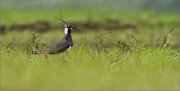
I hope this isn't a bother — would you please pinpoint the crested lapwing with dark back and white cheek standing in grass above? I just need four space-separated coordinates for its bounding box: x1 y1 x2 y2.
34 16 73 54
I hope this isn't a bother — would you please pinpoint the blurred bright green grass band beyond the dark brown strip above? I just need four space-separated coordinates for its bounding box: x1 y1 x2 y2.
0 9 180 26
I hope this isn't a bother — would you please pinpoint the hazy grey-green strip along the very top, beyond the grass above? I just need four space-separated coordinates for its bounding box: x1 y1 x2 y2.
1 0 180 12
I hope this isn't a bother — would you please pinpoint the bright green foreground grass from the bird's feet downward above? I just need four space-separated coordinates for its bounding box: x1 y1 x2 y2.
0 42 180 90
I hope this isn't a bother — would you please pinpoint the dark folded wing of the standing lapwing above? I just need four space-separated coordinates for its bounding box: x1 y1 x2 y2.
47 40 71 54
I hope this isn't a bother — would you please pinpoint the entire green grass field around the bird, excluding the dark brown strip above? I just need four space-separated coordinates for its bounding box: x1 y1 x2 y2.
0 8 180 91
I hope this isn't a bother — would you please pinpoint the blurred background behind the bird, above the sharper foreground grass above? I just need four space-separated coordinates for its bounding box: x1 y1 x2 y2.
0 0 180 48
